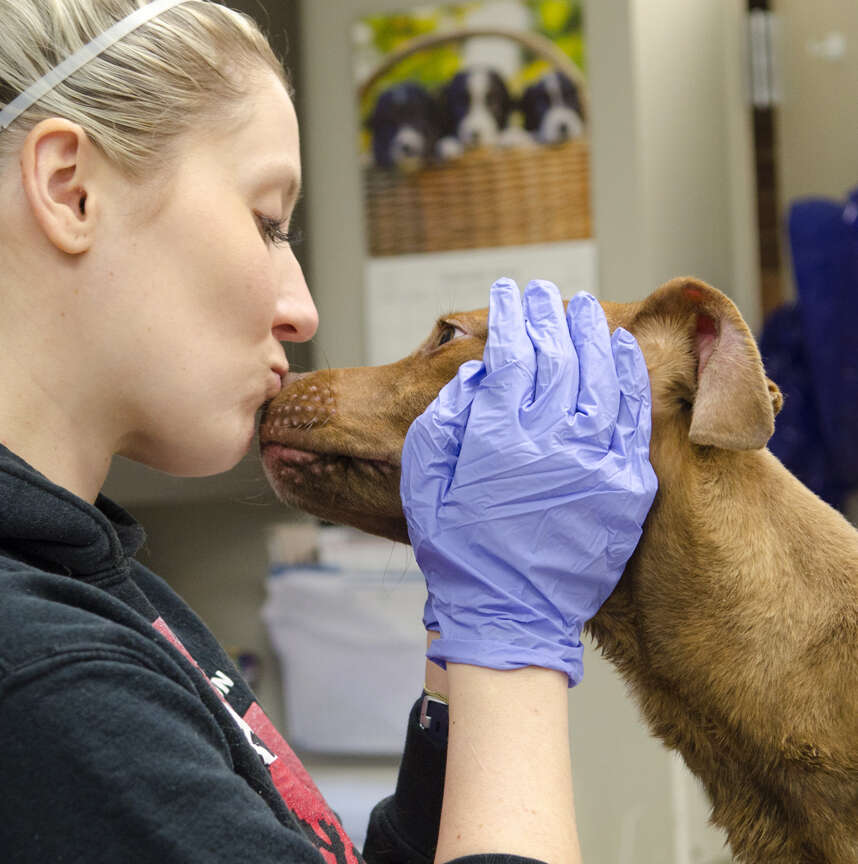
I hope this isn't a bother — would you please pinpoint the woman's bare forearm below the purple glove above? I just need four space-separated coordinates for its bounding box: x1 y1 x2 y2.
436 662 579 864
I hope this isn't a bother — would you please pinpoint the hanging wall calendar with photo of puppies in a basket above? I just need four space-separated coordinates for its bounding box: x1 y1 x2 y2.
352 0 595 362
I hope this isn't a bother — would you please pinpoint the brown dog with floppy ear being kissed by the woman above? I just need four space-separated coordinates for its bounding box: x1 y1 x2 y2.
260 279 858 864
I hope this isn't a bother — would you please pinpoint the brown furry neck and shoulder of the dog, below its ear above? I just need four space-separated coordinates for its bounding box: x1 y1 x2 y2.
588 444 858 862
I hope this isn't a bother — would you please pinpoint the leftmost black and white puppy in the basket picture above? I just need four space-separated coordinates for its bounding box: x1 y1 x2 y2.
369 81 440 169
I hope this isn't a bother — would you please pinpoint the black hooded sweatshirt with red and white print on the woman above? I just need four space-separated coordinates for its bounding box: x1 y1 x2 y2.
0 446 539 864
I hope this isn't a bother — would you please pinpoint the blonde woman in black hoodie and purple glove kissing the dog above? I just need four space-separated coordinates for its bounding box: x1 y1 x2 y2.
0 0 655 864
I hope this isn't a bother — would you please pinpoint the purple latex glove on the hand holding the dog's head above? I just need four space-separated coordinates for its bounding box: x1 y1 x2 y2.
400 279 657 686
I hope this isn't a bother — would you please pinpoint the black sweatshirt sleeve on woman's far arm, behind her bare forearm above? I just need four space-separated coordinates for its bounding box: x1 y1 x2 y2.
363 697 544 864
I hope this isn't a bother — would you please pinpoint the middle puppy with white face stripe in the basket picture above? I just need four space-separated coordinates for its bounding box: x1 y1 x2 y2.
439 67 513 158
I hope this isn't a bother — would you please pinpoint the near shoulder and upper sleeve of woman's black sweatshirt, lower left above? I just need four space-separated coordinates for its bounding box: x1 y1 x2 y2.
0 649 322 864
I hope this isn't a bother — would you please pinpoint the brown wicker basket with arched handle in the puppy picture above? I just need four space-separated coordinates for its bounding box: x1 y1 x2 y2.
359 28 591 257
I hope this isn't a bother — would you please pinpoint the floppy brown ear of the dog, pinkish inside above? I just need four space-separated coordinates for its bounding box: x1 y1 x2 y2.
643 278 782 450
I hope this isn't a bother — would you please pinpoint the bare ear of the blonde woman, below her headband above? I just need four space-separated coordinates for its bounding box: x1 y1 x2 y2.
20 117 97 255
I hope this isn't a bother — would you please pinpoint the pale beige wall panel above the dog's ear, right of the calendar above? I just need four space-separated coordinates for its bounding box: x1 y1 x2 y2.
628 0 759 327
